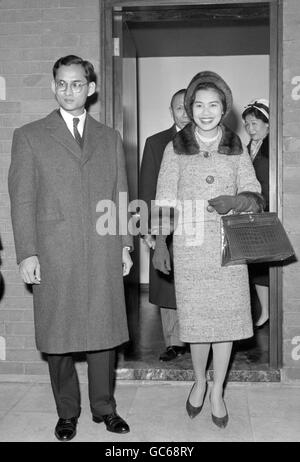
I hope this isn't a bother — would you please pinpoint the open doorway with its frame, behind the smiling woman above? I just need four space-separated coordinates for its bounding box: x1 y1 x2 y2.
101 0 282 381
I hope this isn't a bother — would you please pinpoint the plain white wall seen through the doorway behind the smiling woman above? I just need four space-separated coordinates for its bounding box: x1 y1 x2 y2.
138 55 269 283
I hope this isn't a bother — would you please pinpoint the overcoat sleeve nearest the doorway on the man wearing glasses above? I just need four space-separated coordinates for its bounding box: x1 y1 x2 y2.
115 133 133 250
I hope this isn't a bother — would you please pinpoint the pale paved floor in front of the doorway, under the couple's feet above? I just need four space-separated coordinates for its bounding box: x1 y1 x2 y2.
0 380 300 443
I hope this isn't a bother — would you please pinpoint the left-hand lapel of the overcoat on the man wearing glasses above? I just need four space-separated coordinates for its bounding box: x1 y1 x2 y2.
47 110 82 161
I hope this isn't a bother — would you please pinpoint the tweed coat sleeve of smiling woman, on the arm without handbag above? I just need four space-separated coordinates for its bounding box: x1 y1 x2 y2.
151 142 180 234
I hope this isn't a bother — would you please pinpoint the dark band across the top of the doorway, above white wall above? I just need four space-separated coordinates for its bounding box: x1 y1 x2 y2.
117 3 270 57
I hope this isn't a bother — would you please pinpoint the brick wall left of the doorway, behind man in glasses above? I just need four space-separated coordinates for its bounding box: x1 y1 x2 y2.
0 0 100 375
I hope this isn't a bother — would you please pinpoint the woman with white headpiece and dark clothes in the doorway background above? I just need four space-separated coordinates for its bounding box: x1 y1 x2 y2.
242 99 269 327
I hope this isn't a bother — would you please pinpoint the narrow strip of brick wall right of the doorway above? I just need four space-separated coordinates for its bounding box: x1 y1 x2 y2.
283 0 300 381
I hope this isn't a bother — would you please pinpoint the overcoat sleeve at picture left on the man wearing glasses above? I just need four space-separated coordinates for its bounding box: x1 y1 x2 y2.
8 129 38 264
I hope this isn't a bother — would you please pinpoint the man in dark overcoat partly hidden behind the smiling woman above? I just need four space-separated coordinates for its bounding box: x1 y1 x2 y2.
139 89 189 361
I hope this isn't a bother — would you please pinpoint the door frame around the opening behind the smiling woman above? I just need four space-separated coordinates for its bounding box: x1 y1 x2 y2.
100 0 283 369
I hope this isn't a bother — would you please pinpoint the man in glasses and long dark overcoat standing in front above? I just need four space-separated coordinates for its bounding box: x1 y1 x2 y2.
9 55 132 441
